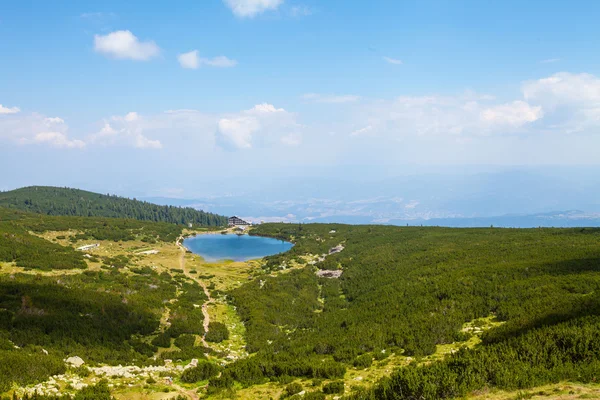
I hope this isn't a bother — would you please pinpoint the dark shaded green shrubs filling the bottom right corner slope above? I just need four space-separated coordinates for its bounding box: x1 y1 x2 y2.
352 314 600 400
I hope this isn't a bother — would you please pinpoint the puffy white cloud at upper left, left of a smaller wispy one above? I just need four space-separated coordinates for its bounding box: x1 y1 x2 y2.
94 31 160 61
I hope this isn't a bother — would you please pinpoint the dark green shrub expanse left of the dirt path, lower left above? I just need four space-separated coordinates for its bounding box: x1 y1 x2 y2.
0 247 210 393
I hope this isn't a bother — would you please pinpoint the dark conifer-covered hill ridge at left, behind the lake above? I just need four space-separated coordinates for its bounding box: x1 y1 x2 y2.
0 186 227 226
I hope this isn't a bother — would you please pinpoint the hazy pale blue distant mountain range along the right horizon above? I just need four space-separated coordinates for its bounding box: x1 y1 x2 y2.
146 170 600 227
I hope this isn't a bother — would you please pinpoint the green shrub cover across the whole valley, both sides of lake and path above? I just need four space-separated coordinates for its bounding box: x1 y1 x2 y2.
0 208 600 400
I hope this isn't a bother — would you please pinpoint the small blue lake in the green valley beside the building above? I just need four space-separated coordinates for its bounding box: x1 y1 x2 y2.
183 234 294 262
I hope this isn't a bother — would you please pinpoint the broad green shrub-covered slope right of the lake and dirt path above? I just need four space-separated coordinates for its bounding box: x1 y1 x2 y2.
212 224 600 399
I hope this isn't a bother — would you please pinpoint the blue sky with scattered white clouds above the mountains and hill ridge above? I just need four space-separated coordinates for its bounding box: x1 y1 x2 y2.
0 0 600 197
